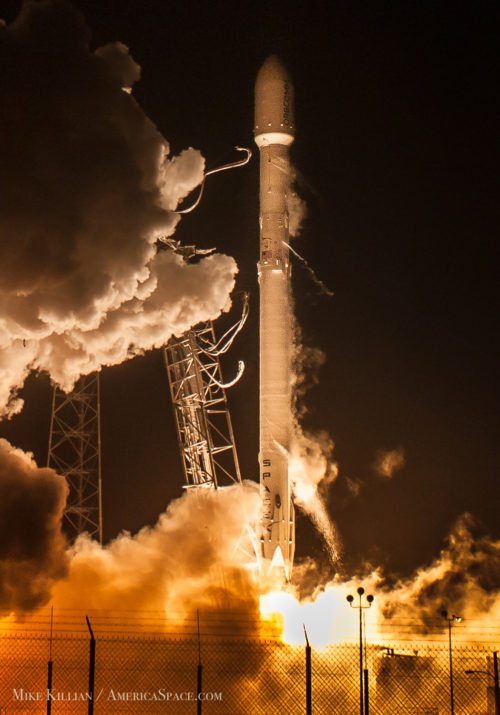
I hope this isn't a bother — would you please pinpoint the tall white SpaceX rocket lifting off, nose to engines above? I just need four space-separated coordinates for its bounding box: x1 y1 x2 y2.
254 56 295 579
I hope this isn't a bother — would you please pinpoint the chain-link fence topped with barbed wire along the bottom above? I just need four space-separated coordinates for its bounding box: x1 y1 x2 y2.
0 632 495 715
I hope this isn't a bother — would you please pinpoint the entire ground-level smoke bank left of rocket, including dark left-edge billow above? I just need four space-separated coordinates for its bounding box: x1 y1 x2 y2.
0 428 261 618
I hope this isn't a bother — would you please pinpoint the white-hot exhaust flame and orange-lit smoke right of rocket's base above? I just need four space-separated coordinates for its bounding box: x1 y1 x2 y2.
260 514 500 647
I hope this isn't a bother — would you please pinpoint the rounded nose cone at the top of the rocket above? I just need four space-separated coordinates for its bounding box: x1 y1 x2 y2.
254 55 295 144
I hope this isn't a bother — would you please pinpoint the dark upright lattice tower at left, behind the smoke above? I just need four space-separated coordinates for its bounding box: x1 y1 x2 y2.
47 372 102 543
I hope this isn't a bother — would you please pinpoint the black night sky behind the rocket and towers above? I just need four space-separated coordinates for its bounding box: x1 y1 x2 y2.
1 0 500 572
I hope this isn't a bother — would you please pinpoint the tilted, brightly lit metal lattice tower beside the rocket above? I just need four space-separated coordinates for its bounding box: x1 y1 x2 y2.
164 322 242 489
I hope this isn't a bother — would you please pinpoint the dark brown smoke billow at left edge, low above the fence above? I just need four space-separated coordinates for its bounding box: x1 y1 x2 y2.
0 439 68 610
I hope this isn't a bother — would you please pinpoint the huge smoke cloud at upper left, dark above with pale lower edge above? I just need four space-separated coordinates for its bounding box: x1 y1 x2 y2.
0 0 236 414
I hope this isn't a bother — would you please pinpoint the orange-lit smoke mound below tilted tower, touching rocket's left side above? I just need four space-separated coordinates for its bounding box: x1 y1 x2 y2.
53 482 260 618
